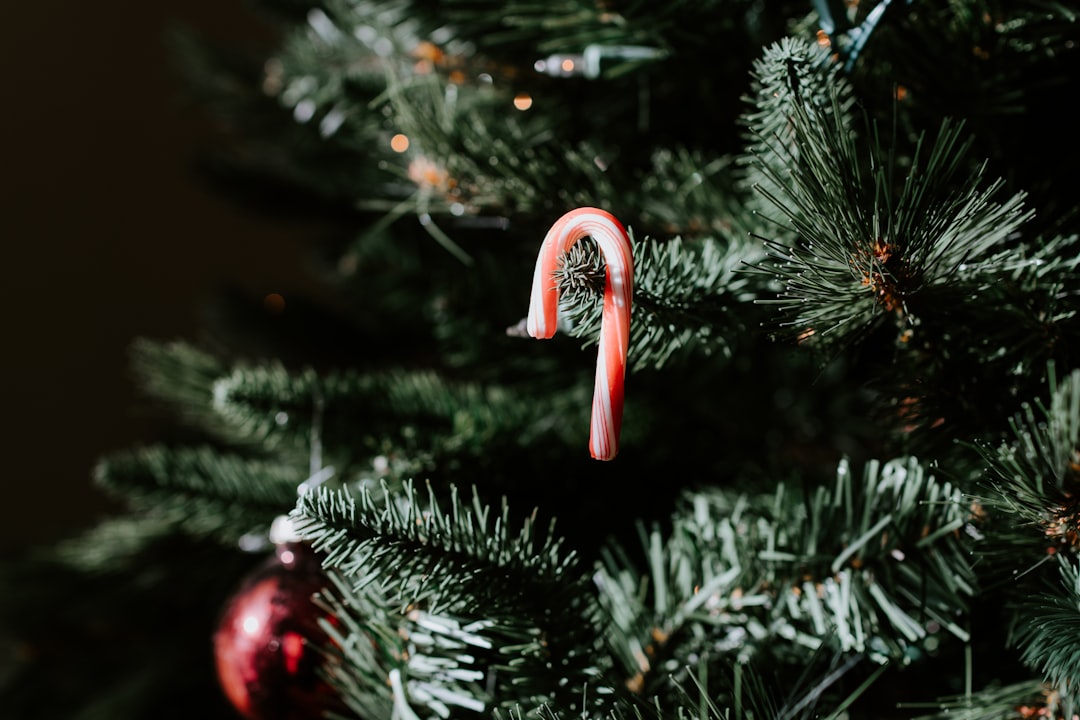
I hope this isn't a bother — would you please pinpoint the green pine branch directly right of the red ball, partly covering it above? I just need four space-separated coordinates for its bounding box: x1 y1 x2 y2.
293 484 604 707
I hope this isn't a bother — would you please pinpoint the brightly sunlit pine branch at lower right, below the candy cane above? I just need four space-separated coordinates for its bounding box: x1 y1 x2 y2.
597 459 975 708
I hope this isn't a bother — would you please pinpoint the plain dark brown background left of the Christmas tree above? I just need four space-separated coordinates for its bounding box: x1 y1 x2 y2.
0 0 314 551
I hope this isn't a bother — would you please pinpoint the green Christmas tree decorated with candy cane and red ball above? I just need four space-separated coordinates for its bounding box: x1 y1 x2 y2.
0 0 1080 720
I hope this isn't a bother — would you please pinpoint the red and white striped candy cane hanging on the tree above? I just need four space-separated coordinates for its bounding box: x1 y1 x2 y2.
527 207 634 460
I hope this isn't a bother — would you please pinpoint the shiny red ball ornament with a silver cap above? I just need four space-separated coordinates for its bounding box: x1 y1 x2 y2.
214 543 334 720
